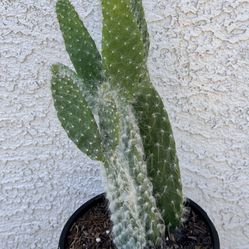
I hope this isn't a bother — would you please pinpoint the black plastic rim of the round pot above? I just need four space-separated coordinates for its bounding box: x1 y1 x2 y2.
58 193 220 249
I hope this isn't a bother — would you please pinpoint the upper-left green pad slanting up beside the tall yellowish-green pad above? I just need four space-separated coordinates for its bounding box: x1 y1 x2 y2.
56 0 103 93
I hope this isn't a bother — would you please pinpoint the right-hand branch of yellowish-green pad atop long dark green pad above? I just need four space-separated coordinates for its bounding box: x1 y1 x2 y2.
102 0 183 227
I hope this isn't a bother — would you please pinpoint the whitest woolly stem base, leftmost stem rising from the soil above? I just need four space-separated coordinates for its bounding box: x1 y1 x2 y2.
102 155 146 249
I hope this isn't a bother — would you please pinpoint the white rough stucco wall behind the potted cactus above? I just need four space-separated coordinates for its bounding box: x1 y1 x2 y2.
0 0 249 249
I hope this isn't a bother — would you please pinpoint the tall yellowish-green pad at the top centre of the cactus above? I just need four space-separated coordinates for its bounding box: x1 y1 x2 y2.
102 0 147 98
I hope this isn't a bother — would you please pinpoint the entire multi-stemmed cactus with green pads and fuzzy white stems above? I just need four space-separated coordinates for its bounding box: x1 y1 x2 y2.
51 0 183 249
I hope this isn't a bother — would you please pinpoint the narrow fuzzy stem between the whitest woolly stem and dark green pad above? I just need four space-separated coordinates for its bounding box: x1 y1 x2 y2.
120 101 165 246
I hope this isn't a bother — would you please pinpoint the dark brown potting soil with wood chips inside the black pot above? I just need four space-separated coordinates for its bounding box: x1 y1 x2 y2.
66 198 213 249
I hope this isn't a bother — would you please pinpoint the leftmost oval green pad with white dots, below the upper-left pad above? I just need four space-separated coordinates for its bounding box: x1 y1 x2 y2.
51 65 103 160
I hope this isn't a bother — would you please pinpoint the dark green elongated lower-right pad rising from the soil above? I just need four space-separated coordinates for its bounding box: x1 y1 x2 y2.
134 87 183 228
